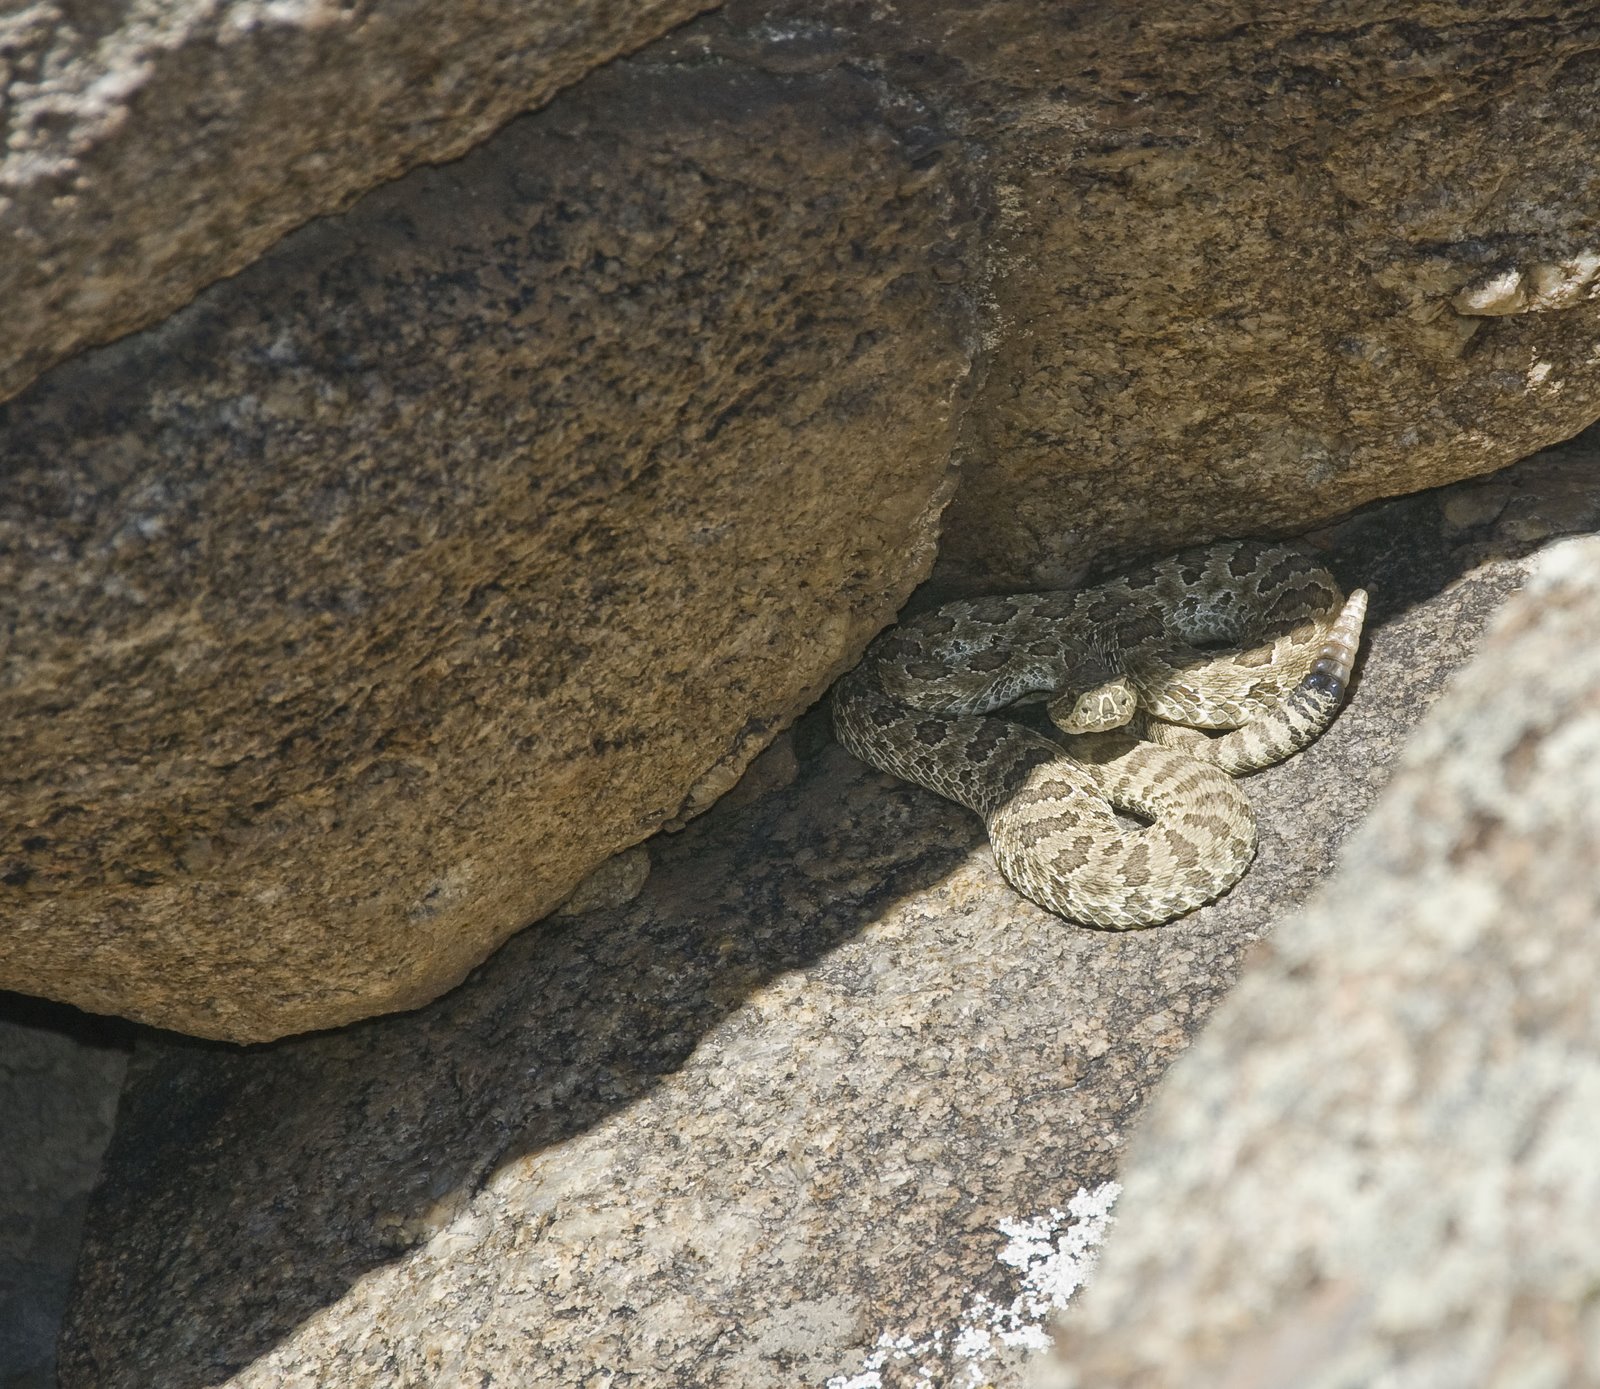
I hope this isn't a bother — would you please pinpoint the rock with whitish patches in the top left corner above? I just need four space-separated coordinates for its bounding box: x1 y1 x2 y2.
0 0 707 400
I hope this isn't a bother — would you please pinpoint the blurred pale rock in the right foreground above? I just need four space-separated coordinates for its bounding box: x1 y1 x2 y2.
1053 538 1600 1389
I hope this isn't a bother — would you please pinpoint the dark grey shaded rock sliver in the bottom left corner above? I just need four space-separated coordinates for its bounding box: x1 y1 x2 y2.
0 994 133 1389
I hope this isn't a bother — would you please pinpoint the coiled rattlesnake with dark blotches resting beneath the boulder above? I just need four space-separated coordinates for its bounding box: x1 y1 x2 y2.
834 541 1366 930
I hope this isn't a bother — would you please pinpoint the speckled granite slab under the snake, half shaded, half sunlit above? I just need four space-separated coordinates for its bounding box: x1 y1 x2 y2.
53 440 1600 1389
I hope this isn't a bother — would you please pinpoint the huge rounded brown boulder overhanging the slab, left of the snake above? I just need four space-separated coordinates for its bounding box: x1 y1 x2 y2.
0 69 968 1040
